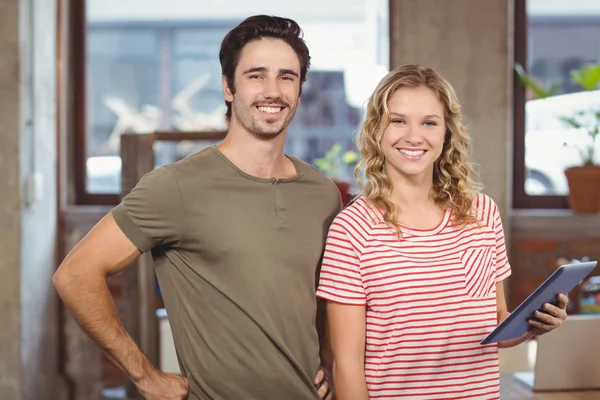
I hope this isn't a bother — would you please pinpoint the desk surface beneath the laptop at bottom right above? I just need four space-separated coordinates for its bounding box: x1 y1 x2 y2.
500 373 600 400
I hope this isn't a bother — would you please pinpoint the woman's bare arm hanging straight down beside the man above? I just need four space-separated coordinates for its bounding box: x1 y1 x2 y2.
327 301 369 400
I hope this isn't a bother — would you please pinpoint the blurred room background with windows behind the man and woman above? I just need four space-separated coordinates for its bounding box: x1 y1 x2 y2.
0 0 600 400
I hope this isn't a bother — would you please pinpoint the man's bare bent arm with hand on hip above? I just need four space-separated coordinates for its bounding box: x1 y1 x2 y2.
53 214 187 399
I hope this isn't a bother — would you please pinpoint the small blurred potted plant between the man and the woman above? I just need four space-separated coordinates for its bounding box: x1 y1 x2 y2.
313 143 358 205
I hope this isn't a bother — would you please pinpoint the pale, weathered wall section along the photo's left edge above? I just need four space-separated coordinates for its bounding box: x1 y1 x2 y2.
0 0 59 400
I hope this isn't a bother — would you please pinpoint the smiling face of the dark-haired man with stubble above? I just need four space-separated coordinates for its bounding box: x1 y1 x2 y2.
222 38 300 139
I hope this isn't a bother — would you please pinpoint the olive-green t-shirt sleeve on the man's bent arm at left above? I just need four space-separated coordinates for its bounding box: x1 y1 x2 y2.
111 166 183 252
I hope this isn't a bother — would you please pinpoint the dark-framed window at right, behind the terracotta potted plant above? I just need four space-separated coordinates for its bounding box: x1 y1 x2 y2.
514 0 600 208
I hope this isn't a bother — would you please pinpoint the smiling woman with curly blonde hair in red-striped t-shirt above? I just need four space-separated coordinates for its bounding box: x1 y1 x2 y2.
317 65 568 400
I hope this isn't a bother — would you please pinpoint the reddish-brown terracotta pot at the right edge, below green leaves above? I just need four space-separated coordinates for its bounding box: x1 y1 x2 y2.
565 165 600 214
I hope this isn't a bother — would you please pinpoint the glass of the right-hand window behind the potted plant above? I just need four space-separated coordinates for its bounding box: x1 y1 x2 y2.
525 0 600 195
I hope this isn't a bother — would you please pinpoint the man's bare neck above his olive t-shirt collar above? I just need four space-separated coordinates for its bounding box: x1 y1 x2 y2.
217 124 296 178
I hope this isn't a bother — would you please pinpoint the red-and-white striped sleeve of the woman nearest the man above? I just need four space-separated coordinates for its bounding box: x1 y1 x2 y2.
317 218 367 305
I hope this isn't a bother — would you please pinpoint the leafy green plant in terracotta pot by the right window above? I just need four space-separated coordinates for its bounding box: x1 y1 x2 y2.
515 64 600 213
